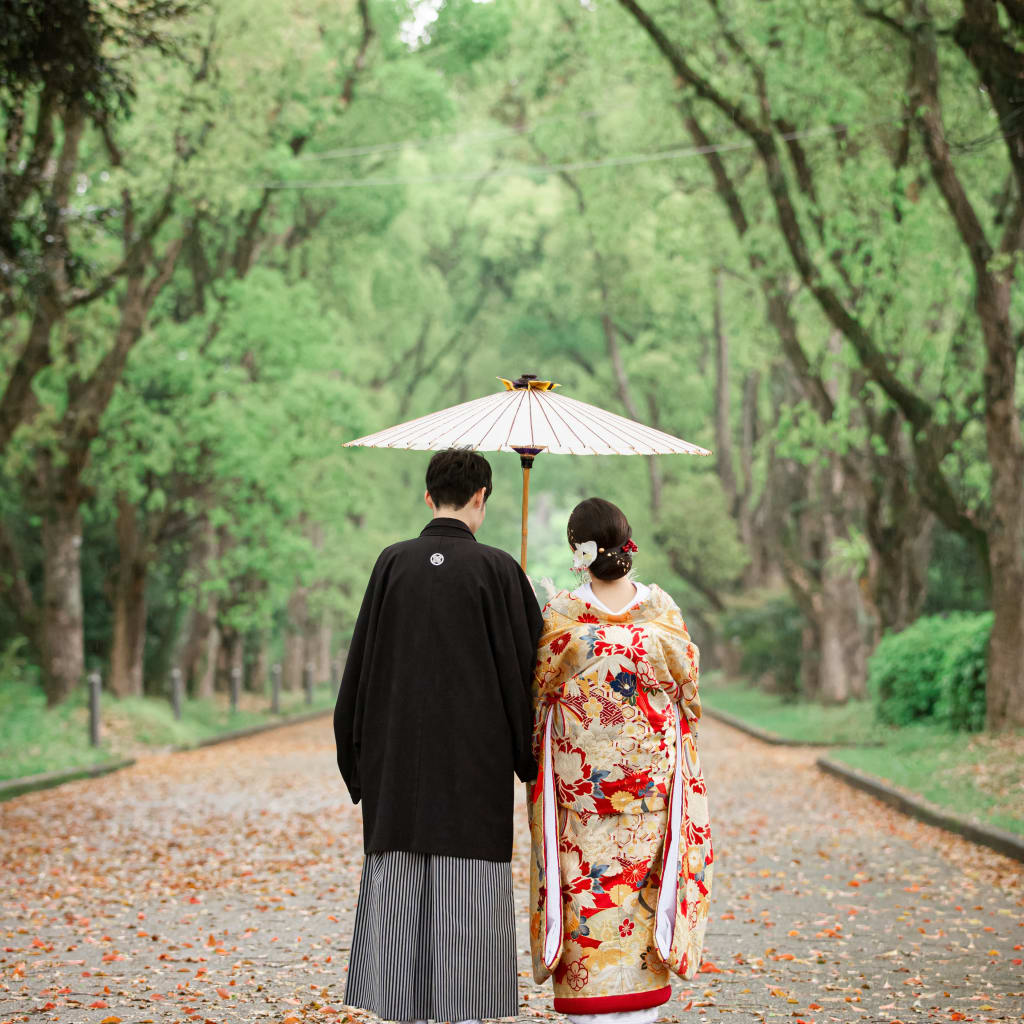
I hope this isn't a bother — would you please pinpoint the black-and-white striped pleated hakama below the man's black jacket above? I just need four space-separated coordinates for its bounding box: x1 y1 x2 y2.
345 851 519 1021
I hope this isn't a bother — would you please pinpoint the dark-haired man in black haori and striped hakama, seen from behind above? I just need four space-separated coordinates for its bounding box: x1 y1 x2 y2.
334 449 542 1021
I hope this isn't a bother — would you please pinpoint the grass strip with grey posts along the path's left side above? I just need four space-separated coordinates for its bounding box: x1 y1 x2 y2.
0 681 334 779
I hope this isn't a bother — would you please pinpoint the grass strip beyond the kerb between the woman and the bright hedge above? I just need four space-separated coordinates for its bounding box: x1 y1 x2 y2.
700 678 890 746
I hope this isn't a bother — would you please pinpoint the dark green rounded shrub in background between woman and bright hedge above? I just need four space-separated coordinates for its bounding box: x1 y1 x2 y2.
719 593 804 700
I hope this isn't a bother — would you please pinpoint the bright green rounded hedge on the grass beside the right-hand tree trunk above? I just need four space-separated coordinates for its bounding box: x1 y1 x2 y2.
867 612 992 732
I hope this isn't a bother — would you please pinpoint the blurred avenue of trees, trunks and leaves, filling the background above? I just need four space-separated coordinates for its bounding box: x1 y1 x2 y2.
0 0 1024 728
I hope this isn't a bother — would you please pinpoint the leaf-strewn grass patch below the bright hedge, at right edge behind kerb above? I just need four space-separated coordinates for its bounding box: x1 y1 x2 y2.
830 725 1024 836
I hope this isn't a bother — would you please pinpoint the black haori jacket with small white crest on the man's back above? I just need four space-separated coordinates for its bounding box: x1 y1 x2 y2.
334 518 543 861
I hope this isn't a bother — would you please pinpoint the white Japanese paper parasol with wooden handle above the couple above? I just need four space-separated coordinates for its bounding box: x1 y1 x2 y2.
345 374 711 570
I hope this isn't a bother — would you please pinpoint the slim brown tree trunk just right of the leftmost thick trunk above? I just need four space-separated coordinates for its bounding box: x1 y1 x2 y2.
110 494 147 697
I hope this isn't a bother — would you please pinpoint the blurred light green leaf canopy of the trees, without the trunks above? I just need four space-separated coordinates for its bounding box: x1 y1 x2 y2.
0 0 1019 722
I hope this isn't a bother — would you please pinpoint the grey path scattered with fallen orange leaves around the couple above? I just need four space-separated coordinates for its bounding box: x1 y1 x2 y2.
0 718 1024 1024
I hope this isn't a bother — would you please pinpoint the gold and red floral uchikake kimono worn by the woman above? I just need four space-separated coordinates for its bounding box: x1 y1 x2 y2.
528 587 714 1014
